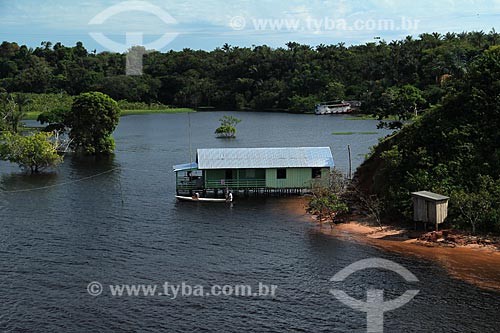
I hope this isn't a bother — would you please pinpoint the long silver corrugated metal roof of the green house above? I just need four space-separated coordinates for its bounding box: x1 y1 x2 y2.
198 147 334 170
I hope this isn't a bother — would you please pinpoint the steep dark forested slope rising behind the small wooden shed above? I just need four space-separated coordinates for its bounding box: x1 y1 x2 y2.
357 46 500 233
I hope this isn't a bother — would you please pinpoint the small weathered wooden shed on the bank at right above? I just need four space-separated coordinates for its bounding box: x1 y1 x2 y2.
411 191 450 230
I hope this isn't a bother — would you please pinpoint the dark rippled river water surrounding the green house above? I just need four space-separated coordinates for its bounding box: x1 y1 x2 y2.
0 112 500 332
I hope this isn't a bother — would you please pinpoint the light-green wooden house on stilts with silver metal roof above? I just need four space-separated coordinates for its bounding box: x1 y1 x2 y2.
174 147 334 197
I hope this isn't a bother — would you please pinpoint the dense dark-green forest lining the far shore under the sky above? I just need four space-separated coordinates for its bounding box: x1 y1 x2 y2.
0 30 500 112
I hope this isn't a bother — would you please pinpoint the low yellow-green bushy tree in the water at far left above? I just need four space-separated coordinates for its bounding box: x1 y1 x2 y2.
0 132 62 174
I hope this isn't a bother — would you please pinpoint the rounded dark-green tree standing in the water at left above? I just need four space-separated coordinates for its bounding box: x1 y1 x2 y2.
66 92 120 155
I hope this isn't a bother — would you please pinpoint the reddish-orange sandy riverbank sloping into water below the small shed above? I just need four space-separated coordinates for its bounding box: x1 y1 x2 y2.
320 218 500 292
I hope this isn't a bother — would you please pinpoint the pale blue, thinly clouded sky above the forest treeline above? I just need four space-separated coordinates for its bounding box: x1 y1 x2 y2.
0 0 500 52
